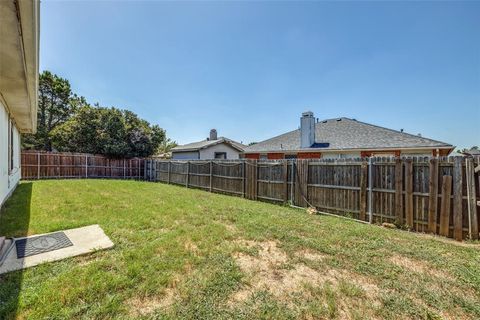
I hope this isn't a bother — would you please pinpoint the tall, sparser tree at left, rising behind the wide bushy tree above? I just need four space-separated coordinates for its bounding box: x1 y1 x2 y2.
22 71 87 151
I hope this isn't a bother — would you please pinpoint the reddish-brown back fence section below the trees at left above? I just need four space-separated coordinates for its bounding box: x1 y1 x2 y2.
21 151 145 180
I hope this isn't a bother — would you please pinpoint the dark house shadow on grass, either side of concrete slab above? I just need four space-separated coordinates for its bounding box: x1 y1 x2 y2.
0 182 32 319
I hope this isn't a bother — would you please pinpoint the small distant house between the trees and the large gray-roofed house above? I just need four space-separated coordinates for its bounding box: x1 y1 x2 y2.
171 129 246 160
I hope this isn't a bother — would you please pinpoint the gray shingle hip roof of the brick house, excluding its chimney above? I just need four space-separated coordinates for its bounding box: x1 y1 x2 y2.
245 118 453 153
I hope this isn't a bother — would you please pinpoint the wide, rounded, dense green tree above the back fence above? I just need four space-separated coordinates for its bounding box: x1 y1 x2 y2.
50 105 166 158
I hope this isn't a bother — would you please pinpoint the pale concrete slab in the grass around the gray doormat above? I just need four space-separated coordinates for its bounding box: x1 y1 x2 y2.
0 225 114 274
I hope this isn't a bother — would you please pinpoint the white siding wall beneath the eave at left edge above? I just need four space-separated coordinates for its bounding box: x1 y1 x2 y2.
0 101 20 205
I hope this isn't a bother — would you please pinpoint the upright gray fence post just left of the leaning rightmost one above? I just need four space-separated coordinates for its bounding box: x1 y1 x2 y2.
453 157 463 241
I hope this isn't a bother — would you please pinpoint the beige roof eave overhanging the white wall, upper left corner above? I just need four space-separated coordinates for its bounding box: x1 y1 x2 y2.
0 0 40 133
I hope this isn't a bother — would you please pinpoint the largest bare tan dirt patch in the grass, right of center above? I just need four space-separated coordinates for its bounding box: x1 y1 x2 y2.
230 241 379 304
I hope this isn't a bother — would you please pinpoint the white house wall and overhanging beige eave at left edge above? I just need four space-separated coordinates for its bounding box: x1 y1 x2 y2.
0 0 40 205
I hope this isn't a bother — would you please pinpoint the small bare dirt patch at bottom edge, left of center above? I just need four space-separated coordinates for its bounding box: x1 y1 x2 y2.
127 288 176 316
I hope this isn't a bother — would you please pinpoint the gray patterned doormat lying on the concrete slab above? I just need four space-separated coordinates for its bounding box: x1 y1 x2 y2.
15 232 73 259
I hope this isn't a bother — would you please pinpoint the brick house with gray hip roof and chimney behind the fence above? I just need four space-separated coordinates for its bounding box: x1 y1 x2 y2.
244 111 454 159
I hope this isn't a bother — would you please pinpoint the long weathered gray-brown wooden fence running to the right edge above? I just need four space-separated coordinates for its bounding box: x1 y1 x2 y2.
145 157 480 240
